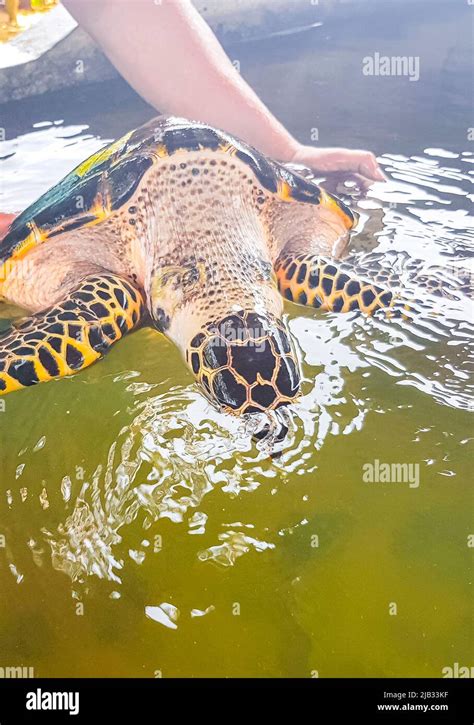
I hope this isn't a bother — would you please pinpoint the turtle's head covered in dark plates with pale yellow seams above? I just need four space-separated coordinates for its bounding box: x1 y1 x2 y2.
187 312 300 414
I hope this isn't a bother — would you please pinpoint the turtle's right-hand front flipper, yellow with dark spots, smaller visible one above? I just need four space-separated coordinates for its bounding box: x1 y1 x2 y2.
275 249 397 315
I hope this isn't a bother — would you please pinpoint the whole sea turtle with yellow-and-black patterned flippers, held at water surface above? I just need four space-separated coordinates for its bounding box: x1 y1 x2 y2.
0 116 392 414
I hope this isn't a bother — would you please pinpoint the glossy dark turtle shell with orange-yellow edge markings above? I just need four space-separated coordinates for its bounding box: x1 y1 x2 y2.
0 116 354 272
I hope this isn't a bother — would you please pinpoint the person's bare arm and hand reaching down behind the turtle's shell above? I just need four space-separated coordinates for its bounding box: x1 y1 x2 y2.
64 0 384 180
